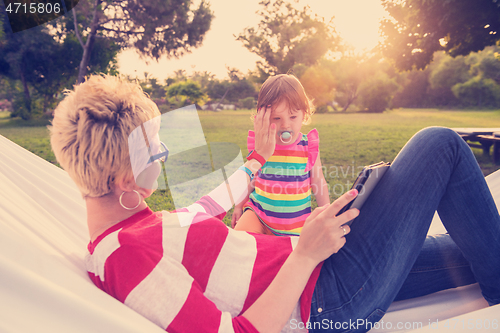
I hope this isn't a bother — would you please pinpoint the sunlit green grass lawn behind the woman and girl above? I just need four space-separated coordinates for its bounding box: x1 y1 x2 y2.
0 109 500 222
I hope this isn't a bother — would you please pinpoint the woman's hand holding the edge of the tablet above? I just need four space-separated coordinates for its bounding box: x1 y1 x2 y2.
294 190 359 265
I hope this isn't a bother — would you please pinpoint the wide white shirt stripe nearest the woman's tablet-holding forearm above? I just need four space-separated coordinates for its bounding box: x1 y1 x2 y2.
205 229 257 317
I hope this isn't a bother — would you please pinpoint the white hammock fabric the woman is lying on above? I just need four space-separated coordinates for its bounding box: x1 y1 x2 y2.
0 136 500 333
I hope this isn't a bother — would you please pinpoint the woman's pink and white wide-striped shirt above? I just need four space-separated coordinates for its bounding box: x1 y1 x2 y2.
86 196 321 333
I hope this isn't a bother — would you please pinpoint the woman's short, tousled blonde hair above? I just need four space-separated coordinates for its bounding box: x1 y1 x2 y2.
49 75 160 197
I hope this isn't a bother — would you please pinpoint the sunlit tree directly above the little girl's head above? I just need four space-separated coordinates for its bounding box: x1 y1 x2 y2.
236 0 339 75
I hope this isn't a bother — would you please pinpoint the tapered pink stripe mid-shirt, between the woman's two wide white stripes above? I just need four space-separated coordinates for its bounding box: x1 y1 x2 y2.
182 219 228 292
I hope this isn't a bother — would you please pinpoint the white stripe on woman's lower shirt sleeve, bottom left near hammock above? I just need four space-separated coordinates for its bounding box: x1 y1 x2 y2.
124 257 193 329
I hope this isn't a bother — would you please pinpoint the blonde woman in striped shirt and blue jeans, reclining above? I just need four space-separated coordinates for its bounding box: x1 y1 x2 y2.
51 76 500 332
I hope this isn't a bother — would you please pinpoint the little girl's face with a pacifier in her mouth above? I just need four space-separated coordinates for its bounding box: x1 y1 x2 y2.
271 101 304 145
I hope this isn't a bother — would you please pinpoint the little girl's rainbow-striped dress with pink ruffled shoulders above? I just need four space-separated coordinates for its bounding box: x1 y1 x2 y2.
243 129 319 236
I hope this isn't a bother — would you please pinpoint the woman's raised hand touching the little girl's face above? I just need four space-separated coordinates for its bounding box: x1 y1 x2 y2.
253 107 276 160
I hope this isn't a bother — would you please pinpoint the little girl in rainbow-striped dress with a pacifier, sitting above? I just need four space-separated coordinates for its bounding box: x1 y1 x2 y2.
231 74 330 236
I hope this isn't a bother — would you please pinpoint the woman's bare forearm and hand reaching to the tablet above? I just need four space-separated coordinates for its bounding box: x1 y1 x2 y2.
243 190 359 332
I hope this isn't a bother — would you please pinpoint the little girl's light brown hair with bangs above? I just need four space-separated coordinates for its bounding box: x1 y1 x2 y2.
257 74 314 124
